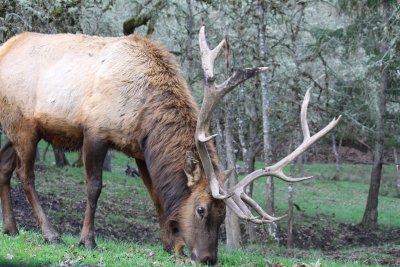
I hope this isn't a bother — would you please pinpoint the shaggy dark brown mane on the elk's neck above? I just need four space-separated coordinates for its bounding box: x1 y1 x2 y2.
144 88 198 219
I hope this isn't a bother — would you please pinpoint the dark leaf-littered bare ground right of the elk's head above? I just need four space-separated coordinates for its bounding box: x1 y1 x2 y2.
221 214 400 267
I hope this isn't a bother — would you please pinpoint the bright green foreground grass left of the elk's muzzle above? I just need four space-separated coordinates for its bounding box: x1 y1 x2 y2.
0 231 175 266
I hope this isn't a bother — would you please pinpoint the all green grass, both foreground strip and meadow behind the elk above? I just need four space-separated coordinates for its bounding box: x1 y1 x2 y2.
0 140 400 267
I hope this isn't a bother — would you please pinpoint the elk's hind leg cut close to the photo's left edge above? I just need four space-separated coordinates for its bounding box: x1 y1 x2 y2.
0 142 18 235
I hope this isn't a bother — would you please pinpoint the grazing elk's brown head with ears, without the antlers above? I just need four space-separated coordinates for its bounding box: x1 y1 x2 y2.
164 151 228 264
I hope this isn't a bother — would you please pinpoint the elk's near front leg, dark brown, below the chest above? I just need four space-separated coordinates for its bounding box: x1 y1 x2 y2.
79 137 109 249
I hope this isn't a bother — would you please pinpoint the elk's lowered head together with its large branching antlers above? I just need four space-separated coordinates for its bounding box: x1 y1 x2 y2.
173 26 340 264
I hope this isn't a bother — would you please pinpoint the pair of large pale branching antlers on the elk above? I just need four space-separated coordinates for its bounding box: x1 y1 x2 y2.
196 26 340 223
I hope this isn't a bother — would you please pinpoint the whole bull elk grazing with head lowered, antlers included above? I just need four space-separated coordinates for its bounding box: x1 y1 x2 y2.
0 27 338 264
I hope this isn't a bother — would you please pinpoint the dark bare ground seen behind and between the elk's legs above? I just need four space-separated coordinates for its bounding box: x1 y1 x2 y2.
11 177 160 244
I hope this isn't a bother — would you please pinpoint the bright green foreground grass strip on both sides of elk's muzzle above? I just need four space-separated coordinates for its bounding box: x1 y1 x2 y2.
0 231 396 267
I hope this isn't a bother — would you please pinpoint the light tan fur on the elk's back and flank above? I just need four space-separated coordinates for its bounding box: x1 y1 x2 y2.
0 33 181 158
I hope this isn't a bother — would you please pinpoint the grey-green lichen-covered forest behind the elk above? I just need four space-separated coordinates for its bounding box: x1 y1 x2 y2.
0 0 400 267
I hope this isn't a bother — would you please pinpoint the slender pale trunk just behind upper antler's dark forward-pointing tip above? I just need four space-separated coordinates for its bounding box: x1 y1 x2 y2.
257 0 278 239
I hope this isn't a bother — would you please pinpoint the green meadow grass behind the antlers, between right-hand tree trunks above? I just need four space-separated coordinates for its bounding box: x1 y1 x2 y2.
248 163 400 227
